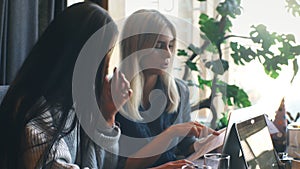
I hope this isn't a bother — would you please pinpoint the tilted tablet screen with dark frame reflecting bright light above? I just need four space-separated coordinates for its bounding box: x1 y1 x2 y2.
236 115 279 169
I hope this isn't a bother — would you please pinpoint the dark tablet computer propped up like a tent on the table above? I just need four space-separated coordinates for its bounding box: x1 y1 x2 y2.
222 115 282 169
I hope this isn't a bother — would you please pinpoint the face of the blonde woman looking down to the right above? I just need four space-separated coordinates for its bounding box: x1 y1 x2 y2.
140 28 175 75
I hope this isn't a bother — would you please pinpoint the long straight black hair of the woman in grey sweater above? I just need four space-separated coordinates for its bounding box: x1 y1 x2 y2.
0 2 117 169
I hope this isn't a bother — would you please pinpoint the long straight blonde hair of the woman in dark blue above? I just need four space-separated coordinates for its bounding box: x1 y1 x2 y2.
120 9 180 121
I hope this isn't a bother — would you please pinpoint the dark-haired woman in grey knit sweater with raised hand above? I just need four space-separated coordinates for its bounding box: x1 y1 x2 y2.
0 2 130 169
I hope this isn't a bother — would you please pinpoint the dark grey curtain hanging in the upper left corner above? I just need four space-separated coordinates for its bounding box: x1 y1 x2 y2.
0 0 67 85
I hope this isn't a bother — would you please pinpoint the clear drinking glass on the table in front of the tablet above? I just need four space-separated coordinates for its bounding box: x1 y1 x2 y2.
204 153 230 169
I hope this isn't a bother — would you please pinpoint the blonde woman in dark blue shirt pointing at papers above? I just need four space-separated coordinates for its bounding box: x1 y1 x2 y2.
116 10 217 168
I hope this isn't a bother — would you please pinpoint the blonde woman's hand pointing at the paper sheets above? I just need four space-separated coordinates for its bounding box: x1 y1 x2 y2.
167 122 220 138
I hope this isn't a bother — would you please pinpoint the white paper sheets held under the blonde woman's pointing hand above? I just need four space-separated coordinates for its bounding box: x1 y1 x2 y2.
187 128 226 161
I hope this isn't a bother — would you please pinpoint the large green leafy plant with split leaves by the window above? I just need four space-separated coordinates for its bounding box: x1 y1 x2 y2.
178 0 300 127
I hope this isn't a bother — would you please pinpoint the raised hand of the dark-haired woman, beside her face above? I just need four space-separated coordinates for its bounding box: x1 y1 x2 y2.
99 68 132 125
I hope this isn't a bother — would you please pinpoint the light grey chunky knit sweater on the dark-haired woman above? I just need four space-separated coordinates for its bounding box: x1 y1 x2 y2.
23 112 121 169
